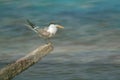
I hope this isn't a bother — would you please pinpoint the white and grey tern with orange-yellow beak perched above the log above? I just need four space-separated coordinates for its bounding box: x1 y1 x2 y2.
26 20 64 39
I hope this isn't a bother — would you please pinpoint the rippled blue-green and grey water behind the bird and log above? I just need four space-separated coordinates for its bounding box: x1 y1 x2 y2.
0 0 120 80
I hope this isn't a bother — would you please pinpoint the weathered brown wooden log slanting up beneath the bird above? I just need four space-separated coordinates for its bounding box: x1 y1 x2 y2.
0 43 53 80
